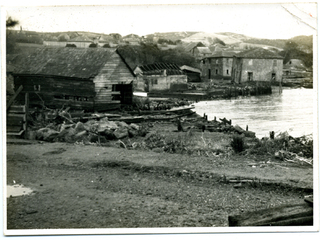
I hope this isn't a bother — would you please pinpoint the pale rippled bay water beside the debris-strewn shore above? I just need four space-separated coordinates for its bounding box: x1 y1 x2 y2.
194 88 316 138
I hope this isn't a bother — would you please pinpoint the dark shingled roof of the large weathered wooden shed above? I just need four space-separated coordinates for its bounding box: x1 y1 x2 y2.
10 47 115 79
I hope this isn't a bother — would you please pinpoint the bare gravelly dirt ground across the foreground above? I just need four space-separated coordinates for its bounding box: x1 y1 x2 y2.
7 124 313 229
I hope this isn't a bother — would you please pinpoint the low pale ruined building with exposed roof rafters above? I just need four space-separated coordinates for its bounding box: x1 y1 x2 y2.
134 63 188 92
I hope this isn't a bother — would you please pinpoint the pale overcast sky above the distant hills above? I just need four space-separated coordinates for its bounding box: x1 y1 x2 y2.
4 1 317 39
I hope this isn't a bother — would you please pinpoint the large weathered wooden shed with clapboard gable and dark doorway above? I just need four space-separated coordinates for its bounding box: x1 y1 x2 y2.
10 47 135 111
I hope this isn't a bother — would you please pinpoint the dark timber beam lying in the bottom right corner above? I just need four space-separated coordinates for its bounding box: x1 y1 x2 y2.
228 202 313 227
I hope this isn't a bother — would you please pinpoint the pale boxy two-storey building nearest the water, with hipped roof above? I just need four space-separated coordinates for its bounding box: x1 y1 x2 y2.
231 48 283 83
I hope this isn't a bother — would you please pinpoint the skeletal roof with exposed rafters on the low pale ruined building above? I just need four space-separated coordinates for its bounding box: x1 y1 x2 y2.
138 63 183 75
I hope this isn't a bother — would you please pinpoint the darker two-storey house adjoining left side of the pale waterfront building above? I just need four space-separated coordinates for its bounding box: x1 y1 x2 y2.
200 51 235 80
